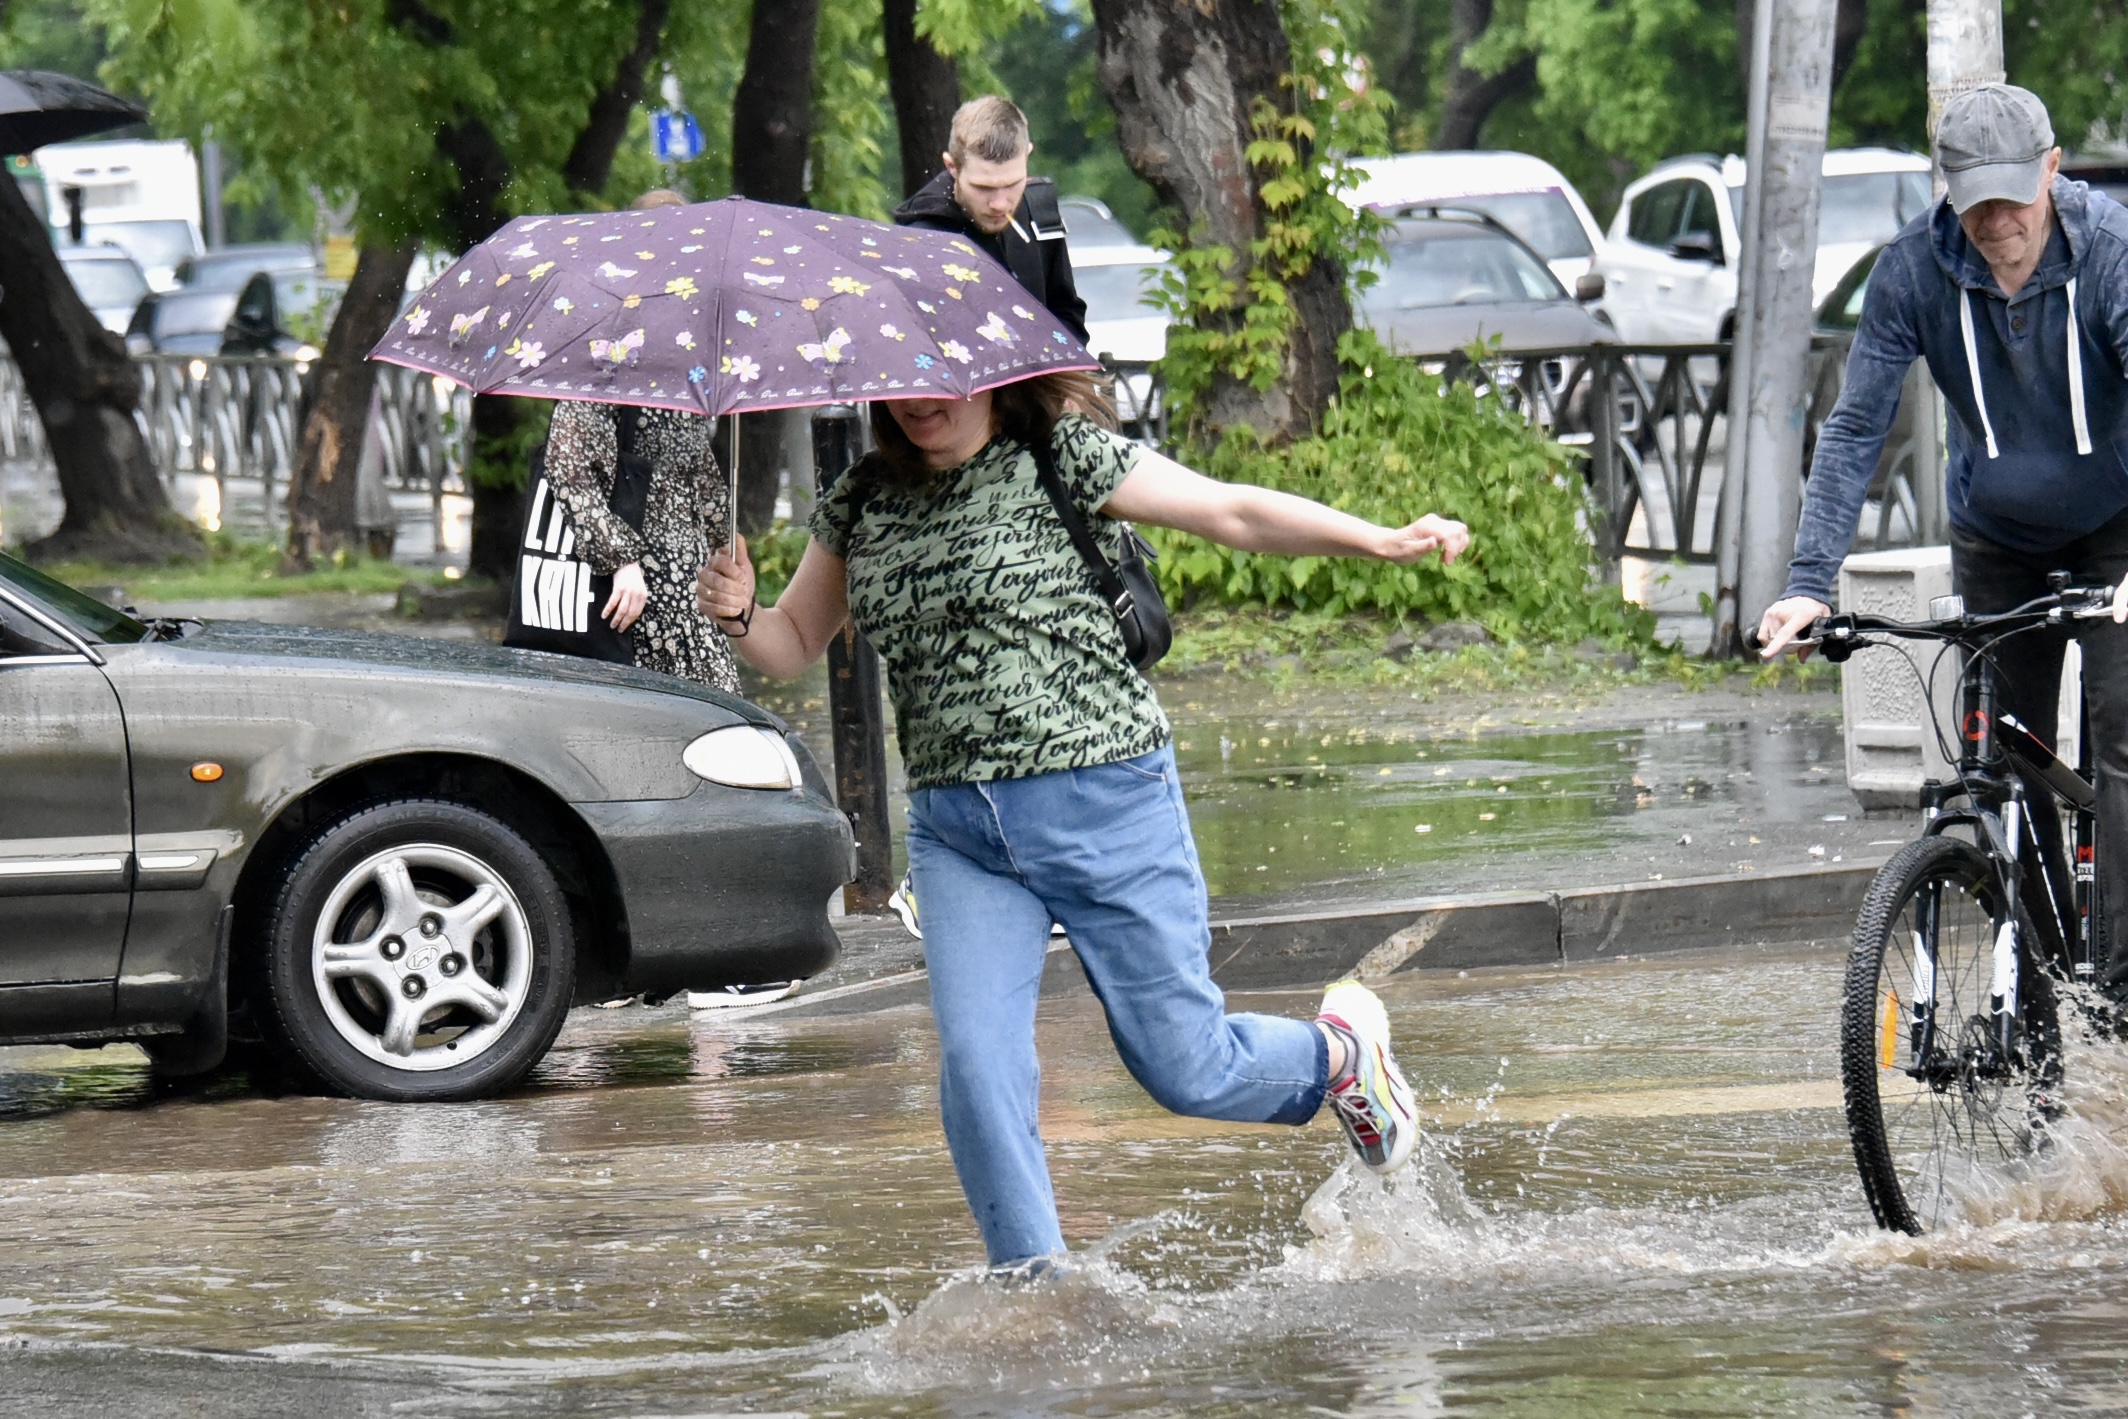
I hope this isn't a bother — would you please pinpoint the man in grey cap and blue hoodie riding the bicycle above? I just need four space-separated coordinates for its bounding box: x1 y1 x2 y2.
1760 83 2128 1002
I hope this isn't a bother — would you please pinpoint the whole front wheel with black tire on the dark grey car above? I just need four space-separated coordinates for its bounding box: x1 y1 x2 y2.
251 800 575 1102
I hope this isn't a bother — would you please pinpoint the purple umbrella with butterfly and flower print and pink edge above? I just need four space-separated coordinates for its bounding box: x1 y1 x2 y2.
370 198 1098 415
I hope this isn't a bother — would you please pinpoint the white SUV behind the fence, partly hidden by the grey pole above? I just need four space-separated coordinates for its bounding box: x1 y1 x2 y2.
1596 149 1930 345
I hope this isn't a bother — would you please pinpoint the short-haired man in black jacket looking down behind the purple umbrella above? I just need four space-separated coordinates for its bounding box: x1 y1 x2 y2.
894 96 1087 345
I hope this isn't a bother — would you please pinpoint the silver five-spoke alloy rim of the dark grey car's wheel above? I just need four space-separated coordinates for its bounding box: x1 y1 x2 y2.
311 842 532 1072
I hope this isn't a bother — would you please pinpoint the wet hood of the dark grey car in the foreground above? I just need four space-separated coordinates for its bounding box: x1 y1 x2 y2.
172 621 787 732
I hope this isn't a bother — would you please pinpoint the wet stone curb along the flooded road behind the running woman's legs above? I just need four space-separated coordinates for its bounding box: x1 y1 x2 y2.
745 862 1881 1019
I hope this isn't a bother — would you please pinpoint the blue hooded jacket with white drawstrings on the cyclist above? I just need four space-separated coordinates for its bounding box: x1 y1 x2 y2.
1785 177 2128 604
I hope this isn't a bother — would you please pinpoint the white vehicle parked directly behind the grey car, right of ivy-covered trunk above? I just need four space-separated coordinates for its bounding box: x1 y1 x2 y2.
1345 153 1602 291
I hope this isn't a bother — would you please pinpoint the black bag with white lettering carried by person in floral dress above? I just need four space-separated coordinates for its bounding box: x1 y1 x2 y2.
502 408 651 666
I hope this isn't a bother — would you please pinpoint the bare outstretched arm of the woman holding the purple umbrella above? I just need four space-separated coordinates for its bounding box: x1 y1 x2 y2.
1100 449 1470 562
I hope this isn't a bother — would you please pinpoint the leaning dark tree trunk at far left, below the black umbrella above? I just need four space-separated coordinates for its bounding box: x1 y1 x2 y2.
0 179 200 562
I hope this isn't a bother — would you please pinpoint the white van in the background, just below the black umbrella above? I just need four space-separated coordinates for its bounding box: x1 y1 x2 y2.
36 140 206 291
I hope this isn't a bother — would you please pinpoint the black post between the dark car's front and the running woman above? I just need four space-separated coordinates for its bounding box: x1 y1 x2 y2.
813 404 894 913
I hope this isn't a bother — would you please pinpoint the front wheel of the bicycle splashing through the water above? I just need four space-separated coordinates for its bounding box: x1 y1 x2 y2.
1841 838 2062 1236
